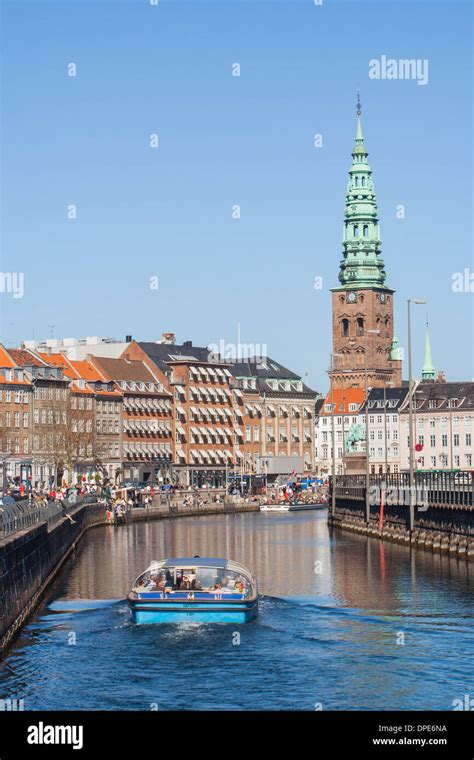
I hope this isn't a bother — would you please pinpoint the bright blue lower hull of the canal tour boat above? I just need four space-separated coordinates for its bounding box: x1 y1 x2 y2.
128 596 258 625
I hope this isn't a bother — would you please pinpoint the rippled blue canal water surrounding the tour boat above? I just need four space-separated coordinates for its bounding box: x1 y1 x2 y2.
0 512 474 710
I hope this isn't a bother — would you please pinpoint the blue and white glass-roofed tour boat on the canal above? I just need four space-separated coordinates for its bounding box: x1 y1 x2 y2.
127 557 258 623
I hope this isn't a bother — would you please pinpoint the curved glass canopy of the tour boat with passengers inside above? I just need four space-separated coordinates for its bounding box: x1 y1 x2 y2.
134 567 251 596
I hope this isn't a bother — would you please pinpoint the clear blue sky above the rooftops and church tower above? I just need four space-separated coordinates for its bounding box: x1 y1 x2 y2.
0 0 474 391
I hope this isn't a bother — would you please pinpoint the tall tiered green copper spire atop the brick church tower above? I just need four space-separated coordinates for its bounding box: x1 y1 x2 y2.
339 96 386 289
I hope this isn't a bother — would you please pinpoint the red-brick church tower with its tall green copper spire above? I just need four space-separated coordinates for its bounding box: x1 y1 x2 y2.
332 99 402 388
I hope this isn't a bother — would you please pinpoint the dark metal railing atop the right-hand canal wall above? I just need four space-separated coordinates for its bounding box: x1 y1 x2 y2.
331 471 474 508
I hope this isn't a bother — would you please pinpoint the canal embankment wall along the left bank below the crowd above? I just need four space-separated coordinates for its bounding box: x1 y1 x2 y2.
0 498 259 655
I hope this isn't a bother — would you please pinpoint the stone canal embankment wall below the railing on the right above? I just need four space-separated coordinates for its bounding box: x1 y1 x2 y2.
328 496 474 562
